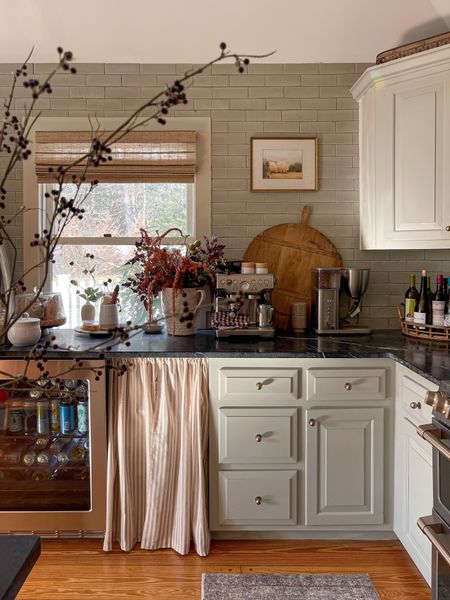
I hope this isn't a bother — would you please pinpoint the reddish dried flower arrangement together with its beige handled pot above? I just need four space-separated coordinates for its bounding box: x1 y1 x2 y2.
124 228 225 335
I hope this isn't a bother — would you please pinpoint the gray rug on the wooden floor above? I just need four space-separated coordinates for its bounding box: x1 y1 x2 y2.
202 573 380 600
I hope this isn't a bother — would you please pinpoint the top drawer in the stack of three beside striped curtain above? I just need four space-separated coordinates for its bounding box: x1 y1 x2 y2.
219 367 299 403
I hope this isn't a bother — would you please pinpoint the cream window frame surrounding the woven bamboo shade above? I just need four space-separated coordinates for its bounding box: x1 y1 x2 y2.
23 117 211 289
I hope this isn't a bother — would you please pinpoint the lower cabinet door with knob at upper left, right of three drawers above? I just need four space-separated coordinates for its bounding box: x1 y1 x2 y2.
305 407 384 525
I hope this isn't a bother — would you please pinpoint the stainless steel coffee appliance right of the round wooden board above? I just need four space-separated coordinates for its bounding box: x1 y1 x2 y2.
312 267 372 335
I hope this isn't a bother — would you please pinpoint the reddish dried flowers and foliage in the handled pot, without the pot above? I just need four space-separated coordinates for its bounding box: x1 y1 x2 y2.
123 227 225 310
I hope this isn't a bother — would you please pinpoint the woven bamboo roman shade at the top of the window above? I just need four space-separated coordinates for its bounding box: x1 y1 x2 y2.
35 131 196 183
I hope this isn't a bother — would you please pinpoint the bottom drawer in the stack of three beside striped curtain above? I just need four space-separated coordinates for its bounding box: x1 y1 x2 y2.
219 471 297 525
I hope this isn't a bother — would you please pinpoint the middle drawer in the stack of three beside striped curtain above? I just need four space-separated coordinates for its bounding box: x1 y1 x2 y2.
219 408 298 464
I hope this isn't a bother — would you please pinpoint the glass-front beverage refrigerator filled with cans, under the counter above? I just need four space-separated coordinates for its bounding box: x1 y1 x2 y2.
0 360 106 537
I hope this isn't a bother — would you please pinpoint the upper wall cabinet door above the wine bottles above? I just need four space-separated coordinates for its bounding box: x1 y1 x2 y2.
374 75 450 249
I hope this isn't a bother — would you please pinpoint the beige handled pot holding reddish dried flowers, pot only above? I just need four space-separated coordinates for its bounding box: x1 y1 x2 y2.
161 288 206 335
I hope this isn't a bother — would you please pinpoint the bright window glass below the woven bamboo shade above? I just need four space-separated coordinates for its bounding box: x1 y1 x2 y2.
49 183 195 327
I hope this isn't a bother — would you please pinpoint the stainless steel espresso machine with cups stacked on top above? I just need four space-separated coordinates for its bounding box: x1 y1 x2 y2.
212 273 275 338
